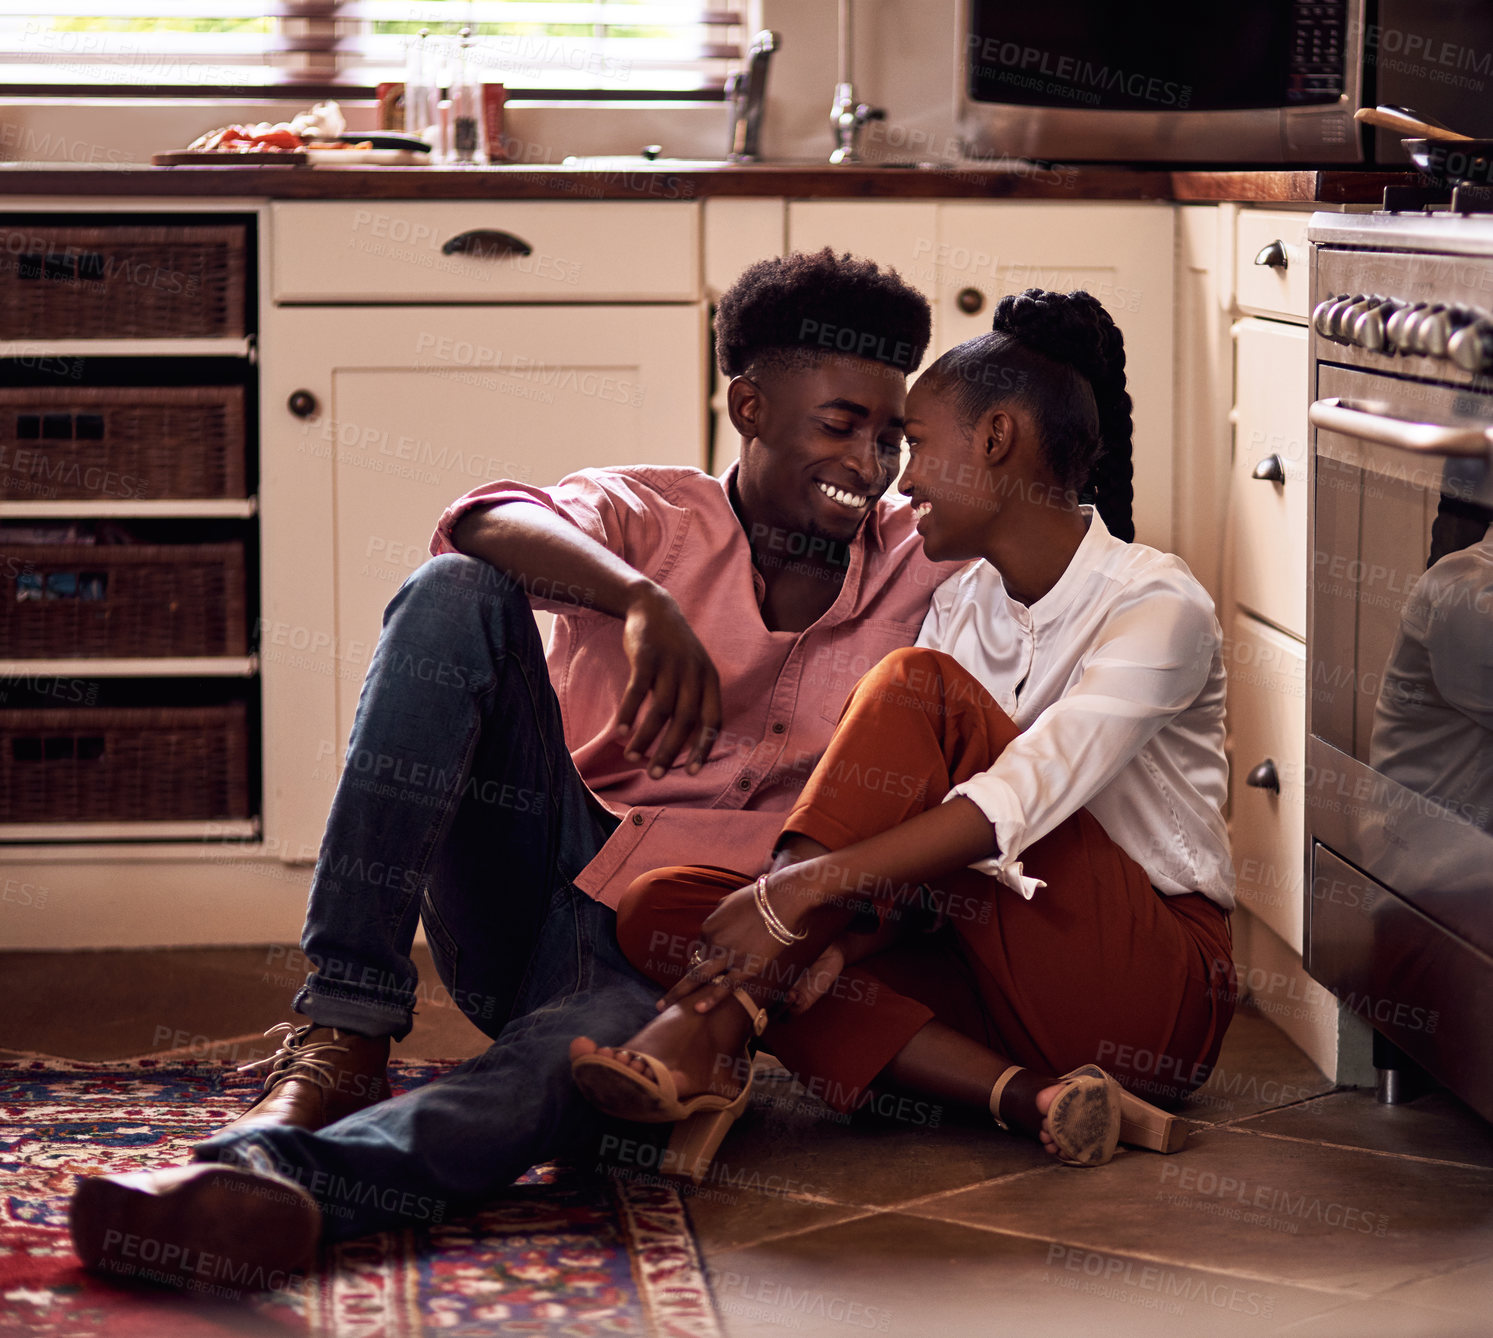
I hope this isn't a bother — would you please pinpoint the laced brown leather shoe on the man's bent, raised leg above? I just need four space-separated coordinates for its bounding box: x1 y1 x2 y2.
224 1021 390 1129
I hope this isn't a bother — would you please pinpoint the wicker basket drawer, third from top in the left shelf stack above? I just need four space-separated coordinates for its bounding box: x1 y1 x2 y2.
0 536 248 660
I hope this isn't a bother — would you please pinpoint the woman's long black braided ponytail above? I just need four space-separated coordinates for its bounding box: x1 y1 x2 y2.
991 288 1135 542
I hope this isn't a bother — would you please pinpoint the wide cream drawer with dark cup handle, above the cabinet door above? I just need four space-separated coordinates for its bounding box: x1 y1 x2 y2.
270 200 700 302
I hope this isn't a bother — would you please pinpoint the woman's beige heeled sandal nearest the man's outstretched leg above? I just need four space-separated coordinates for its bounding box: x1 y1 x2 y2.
570 989 767 1184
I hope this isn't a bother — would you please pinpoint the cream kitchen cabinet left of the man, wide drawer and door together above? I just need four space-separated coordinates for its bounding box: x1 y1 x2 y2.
260 202 708 851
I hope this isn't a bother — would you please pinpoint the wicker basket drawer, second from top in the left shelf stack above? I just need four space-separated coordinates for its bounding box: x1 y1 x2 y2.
0 385 246 502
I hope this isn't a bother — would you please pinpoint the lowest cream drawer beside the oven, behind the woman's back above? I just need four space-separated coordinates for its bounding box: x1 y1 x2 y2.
1224 615 1306 951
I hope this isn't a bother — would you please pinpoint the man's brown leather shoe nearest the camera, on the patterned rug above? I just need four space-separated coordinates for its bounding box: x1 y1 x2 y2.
67 1162 321 1298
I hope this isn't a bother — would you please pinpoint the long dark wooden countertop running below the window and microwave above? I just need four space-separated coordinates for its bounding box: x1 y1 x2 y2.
0 163 1417 205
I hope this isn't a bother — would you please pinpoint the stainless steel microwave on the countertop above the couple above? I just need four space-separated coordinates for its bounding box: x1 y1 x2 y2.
957 0 1493 166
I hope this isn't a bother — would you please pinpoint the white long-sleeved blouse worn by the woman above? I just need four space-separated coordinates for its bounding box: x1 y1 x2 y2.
918 506 1233 909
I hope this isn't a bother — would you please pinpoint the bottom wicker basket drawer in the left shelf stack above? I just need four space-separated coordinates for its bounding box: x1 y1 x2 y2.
0 702 251 823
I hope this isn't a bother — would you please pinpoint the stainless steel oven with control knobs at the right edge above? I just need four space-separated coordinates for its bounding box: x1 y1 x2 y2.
1302 209 1493 1118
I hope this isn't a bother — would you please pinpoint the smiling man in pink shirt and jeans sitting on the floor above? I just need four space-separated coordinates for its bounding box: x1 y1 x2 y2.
72 249 953 1286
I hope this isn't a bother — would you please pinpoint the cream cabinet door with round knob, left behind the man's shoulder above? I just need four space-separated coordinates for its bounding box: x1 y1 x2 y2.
260 303 706 857
